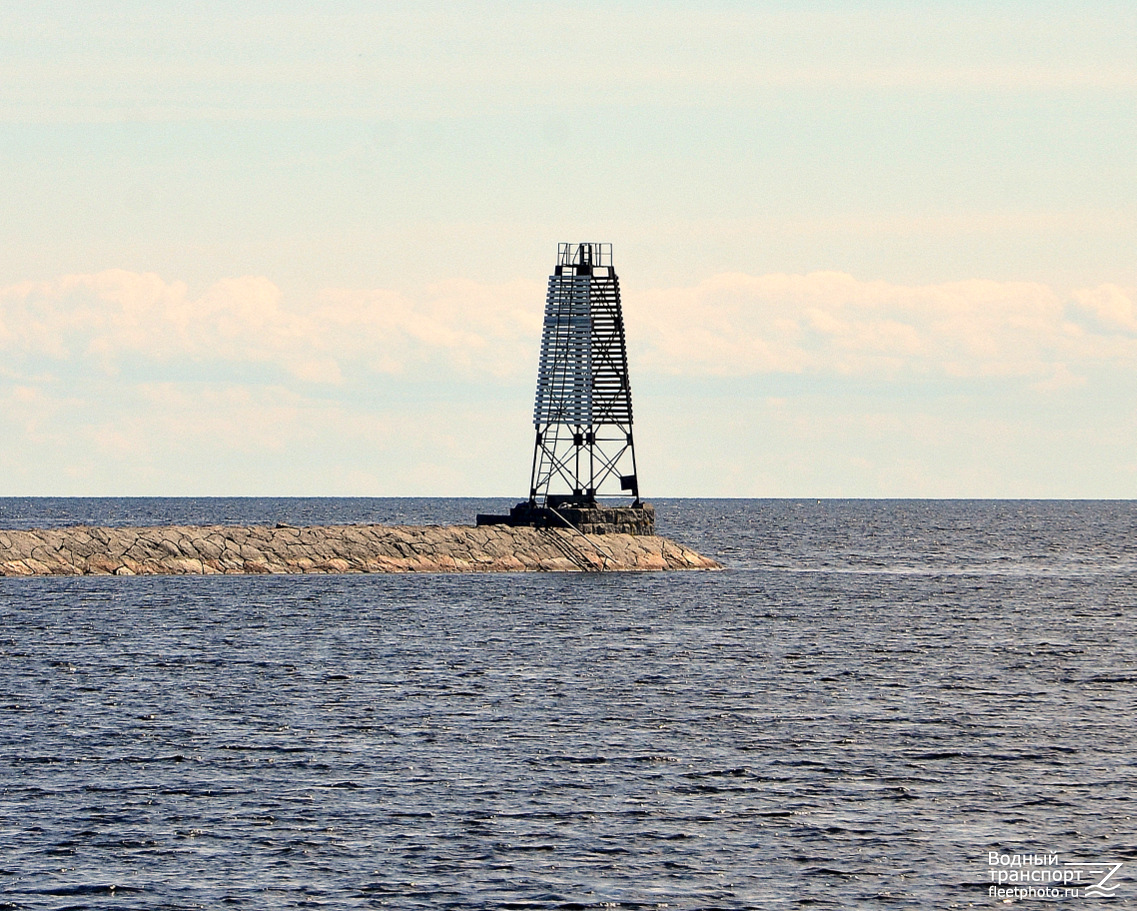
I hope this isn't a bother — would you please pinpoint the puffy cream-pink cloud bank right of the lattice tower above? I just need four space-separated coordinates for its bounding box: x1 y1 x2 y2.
628 272 1137 386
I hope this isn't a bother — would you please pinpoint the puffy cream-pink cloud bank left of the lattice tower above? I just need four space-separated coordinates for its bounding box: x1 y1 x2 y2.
0 270 541 384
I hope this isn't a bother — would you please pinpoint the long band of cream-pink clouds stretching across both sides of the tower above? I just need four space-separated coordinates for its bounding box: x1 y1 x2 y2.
0 264 1137 388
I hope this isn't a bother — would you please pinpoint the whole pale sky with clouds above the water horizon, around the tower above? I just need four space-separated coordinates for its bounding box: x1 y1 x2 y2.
0 0 1137 499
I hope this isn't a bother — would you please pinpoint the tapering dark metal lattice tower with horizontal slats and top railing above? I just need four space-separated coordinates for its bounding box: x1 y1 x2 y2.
529 243 639 506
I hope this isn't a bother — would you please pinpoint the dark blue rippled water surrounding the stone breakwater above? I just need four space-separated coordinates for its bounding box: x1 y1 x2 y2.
0 499 1137 909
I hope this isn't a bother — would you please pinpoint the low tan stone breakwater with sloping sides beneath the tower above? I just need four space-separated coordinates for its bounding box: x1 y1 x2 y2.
0 525 720 575
